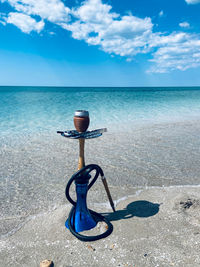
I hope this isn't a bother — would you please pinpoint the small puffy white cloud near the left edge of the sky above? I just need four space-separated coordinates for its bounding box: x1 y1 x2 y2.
6 12 44 33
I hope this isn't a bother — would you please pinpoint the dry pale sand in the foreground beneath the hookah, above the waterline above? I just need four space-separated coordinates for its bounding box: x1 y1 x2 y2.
0 187 200 267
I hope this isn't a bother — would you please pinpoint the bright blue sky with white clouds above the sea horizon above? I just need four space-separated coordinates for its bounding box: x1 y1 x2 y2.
0 0 200 86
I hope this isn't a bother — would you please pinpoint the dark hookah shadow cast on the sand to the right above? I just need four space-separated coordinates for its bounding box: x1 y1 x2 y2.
102 200 160 221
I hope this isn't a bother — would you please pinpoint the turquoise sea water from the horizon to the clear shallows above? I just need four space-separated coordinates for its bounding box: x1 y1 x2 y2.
0 87 200 135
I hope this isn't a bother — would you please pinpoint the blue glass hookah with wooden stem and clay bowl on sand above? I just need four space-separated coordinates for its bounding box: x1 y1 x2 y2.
57 110 115 241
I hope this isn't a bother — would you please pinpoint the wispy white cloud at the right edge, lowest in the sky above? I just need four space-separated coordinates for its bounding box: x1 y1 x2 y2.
149 33 200 73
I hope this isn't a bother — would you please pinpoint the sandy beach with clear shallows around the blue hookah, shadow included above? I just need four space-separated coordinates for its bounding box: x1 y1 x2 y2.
0 121 200 267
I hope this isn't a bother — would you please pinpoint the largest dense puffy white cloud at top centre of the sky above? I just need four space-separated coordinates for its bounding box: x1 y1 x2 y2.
61 0 153 57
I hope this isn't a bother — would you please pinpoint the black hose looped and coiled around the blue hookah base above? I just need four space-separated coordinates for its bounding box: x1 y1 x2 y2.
65 164 115 242
